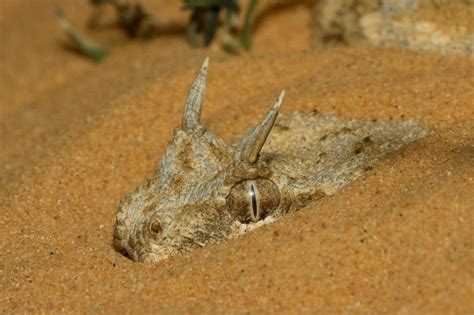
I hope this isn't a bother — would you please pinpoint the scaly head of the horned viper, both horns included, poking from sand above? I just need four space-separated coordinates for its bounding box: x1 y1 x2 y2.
114 59 426 261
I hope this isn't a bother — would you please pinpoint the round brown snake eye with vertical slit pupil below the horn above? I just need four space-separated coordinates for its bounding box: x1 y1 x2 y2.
226 179 280 222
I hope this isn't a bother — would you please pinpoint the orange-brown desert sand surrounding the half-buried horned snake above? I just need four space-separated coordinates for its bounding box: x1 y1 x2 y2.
0 0 474 314
